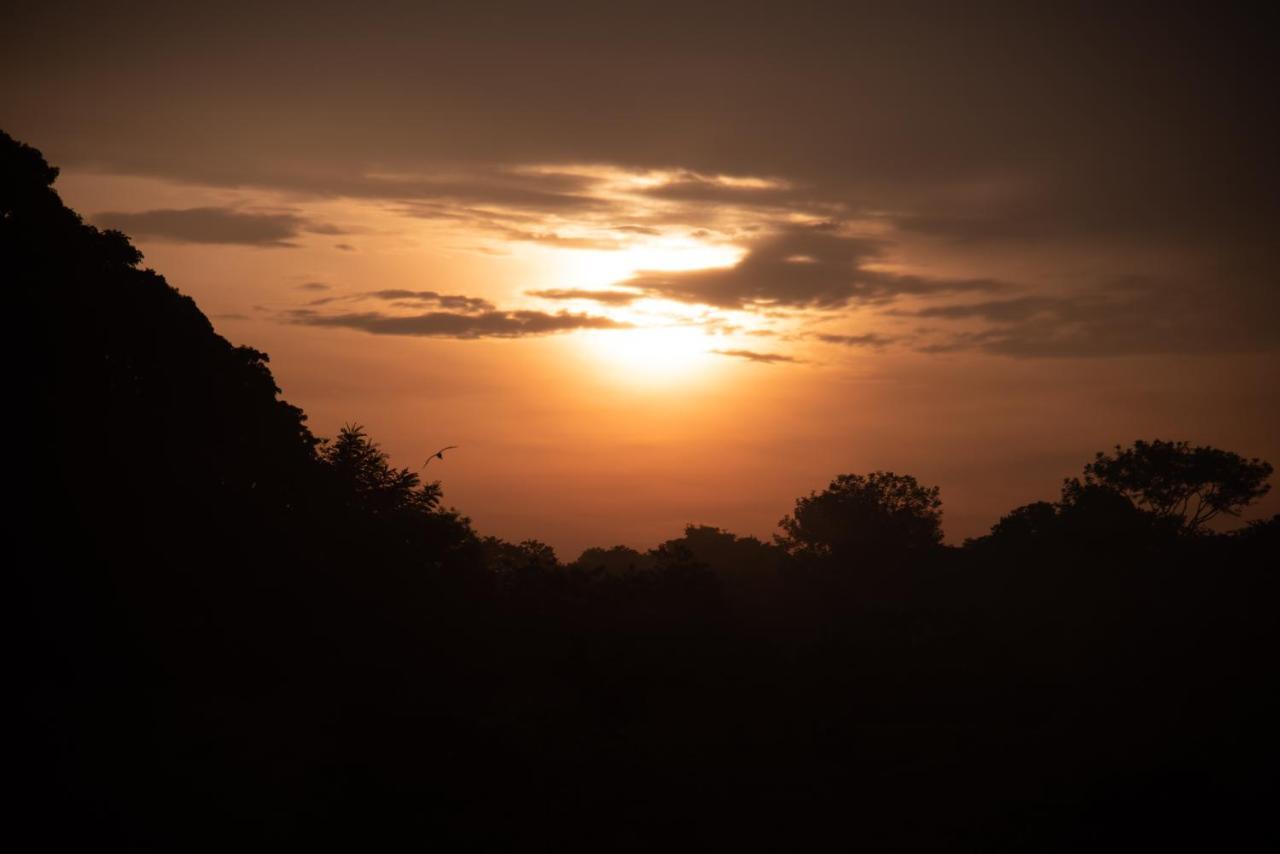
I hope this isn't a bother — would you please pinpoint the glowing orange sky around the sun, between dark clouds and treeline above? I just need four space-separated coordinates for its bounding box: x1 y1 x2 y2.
47 169 1280 558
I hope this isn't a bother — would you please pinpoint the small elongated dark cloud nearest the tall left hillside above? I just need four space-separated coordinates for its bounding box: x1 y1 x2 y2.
93 207 328 247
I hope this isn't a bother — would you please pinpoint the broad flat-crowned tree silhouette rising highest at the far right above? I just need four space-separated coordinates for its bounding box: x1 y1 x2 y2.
1084 439 1272 534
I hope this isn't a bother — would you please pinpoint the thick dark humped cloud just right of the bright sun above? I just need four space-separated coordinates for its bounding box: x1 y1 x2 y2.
622 223 1006 309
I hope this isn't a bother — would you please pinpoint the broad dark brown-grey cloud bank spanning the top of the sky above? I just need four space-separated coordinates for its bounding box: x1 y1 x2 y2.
24 3 1277 270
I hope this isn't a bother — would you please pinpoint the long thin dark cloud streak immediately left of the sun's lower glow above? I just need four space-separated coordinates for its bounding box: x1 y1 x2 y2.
287 309 631 339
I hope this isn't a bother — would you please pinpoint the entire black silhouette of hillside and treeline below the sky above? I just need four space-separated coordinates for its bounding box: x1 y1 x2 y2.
10 133 1280 851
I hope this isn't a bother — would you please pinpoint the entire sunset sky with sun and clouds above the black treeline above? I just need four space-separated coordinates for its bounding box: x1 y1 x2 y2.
0 1 1280 558
